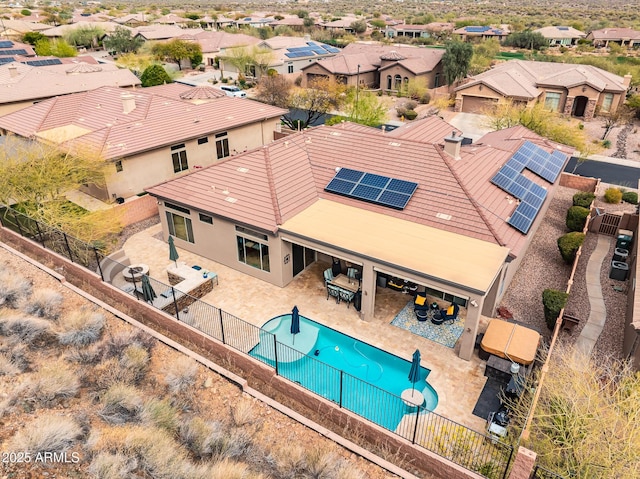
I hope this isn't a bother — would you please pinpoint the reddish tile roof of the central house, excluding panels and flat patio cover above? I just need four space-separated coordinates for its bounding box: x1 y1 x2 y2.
147 124 568 254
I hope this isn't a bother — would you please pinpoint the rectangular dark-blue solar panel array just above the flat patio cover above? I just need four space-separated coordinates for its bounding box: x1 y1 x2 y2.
325 168 418 210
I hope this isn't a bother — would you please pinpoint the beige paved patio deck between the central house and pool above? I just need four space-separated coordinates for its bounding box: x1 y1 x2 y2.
123 224 487 432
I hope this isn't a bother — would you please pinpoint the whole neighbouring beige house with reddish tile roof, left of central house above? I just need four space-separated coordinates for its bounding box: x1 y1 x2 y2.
0 83 287 200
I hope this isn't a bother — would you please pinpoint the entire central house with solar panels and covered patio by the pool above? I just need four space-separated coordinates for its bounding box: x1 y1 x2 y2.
147 119 570 360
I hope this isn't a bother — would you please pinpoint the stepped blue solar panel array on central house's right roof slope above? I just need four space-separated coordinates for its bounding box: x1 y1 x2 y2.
491 141 566 234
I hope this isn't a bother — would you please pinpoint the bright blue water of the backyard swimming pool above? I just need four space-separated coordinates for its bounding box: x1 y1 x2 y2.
250 314 438 431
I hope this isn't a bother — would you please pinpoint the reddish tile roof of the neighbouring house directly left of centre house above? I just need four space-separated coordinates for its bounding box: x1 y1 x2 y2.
0 85 286 159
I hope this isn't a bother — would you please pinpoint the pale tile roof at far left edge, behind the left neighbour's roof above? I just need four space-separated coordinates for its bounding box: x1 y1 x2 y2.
0 63 140 103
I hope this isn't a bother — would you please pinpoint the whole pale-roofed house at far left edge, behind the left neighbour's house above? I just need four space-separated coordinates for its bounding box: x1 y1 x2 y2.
0 57 140 115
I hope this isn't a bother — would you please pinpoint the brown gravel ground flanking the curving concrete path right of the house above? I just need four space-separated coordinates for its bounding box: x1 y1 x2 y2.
501 185 635 358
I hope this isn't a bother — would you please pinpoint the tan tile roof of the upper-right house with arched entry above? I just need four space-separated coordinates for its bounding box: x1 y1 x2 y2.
456 60 626 99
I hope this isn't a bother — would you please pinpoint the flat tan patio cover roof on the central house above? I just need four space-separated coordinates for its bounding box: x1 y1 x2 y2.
280 199 509 294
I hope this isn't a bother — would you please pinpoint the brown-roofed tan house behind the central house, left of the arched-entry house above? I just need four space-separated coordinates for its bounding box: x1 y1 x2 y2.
302 43 444 92
